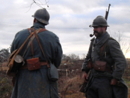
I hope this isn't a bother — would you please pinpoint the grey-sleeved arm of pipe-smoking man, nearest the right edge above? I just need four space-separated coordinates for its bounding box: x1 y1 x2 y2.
108 40 127 80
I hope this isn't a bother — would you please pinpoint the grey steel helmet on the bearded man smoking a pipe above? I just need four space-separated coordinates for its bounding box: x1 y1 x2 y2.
90 16 108 27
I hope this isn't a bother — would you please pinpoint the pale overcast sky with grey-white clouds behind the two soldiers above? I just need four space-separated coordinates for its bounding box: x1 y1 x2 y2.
0 0 130 57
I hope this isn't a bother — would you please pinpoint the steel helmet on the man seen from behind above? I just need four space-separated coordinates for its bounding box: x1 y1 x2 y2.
32 8 50 24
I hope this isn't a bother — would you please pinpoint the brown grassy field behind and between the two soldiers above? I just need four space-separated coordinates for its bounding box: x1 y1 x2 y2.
0 61 130 98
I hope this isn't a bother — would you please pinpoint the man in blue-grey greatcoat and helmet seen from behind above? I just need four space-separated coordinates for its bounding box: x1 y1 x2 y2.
11 8 62 98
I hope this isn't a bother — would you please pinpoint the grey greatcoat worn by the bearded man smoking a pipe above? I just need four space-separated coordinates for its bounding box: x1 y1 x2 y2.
82 32 128 98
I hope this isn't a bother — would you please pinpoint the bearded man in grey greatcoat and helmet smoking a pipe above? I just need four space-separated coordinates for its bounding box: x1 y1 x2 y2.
82 16 128 98
